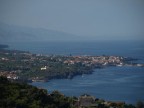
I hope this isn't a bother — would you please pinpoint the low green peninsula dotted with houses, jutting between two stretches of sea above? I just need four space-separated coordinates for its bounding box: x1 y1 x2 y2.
0 49 140 81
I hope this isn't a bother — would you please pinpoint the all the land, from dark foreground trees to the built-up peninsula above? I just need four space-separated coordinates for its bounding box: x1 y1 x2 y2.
0 46 144 108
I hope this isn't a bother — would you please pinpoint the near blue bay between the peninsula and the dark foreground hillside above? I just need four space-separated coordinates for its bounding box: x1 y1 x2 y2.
32 67 144 104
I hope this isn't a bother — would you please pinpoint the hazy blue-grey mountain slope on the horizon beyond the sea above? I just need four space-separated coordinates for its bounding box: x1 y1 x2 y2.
0 23 80 42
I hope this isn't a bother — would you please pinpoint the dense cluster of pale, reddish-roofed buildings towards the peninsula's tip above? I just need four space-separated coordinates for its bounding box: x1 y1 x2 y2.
64 56 124 66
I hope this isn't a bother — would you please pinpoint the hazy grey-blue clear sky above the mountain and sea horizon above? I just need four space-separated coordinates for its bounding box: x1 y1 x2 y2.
0 0 144 40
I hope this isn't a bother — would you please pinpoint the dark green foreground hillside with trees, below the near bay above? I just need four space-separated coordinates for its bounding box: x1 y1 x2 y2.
0 77 138 108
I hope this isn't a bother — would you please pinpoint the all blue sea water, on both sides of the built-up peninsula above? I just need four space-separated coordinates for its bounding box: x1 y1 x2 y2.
6 40 144 104
